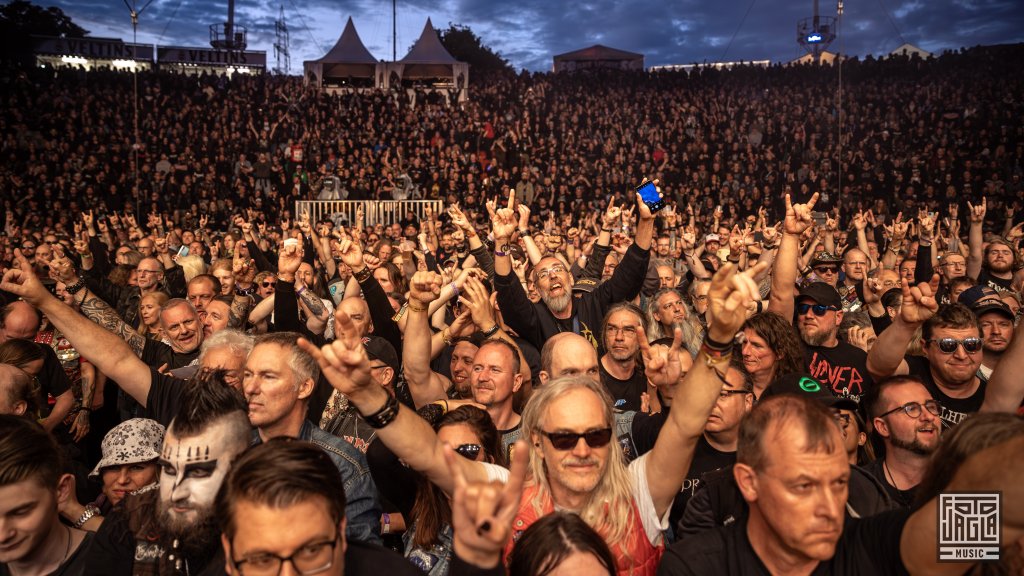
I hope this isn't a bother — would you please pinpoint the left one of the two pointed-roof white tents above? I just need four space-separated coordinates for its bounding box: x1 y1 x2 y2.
302 16 385 88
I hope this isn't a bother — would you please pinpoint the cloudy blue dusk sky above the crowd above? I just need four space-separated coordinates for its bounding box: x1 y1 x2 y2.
35 0 1024 74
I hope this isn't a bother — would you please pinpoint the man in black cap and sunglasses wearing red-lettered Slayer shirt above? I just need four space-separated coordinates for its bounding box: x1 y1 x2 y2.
796 282 871 402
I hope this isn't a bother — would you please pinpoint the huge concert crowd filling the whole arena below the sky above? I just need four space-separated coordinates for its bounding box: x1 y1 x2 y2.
0 41 1024 576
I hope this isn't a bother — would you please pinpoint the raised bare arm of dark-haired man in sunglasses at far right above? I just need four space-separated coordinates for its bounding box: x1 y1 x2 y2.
867 282 939 380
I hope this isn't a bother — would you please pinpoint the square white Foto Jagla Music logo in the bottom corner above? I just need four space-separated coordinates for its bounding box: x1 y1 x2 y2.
939 492 1002 562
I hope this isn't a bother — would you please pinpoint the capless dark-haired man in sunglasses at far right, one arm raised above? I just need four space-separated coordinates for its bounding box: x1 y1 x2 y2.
867 276 988 427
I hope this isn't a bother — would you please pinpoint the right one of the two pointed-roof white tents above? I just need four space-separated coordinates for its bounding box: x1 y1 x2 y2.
384 18 469 101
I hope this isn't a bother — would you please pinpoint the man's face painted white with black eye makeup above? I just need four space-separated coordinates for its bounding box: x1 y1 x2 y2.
158 419 238 528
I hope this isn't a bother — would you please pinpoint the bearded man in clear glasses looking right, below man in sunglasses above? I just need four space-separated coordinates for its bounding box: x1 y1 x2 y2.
865 376 942 507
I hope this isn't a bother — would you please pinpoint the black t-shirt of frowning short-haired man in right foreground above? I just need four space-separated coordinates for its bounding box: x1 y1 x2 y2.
657 510 910 576
